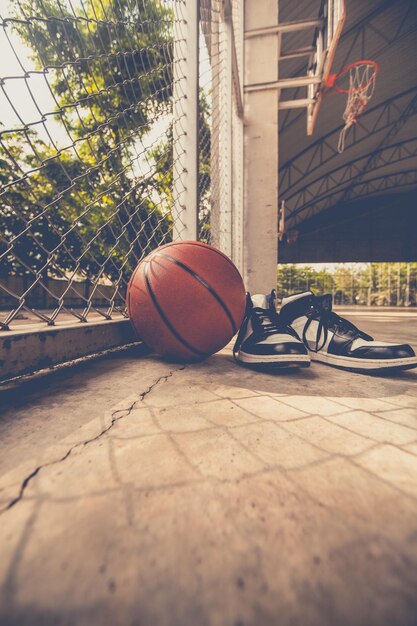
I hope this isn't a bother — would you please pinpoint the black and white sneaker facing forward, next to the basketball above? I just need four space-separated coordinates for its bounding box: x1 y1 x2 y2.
233 291 310 369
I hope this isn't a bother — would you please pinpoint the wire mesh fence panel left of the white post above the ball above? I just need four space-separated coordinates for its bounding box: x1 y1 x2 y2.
0 0 186 330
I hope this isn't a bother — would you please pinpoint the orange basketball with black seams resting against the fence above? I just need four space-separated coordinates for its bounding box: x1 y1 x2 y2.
126 241 245 361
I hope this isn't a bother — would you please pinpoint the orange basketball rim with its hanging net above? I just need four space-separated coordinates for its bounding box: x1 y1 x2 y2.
326 61 378 153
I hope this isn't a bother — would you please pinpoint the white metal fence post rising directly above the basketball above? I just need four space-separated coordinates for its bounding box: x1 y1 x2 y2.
172 0 199 241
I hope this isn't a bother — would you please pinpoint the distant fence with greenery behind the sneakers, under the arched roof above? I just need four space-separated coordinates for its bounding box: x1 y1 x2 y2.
278 263 417 306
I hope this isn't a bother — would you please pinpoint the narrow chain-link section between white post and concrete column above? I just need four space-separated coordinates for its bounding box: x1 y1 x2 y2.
199 0 243 267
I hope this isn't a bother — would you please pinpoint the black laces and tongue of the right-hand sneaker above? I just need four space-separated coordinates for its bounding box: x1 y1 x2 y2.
303 294 372 352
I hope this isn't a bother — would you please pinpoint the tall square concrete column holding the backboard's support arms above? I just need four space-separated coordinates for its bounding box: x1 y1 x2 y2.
243 0 280 293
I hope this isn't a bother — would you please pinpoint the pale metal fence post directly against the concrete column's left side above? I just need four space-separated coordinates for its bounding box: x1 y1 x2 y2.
206 0 243 270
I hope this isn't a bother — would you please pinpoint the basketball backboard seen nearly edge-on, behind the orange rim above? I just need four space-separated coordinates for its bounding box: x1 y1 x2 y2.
307 0 346 135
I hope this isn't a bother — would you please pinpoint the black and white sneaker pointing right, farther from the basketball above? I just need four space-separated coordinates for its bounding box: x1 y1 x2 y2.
280 291 417 372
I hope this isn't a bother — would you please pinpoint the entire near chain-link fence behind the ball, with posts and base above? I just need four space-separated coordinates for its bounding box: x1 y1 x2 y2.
0 0 243 377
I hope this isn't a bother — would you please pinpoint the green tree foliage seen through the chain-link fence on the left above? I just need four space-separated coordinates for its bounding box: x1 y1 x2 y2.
0 0 172 280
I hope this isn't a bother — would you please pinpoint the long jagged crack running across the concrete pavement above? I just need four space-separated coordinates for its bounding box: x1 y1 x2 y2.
0 365 185 515
